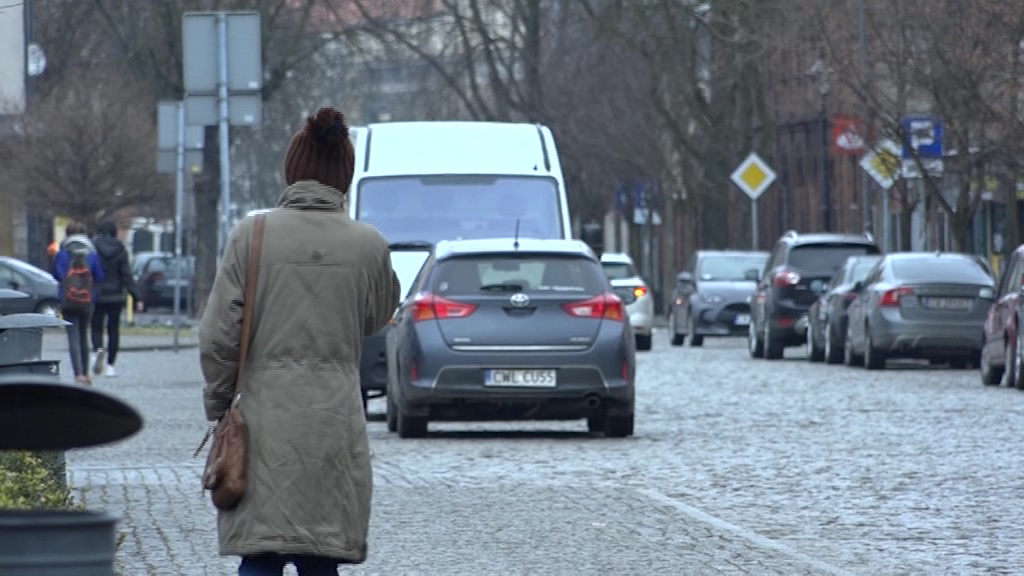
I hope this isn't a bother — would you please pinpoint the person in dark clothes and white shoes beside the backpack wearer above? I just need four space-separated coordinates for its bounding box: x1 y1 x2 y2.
92 221 143 377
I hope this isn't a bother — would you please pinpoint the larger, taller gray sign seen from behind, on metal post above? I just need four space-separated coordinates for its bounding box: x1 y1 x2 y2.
181 11 263 258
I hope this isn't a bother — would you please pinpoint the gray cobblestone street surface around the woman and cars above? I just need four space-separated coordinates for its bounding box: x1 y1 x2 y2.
58 333 1024 576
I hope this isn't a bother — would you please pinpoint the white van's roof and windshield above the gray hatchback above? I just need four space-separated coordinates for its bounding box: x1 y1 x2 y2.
348 122 572 244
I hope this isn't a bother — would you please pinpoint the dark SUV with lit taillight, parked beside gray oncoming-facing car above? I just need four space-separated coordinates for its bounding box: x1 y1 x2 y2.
748 231 882 360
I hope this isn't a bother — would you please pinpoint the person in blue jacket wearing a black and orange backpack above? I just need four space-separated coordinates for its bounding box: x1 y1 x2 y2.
53 222 104 385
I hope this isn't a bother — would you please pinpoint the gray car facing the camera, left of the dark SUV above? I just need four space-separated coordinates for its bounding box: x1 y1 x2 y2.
669 250 768 346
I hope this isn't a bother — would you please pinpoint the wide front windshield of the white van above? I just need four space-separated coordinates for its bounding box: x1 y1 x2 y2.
355 174 563 243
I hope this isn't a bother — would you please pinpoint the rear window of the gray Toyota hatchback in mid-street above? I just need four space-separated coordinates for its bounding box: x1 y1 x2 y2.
431 254 607 295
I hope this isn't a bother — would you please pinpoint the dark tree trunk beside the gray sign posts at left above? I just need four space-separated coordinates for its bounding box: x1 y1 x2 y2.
194 126 220 318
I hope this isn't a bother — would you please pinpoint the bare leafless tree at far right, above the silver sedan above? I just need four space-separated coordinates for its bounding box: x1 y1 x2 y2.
821 0 1024 250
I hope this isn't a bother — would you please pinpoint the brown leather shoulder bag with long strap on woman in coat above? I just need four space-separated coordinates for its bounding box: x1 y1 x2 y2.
203 214 264 510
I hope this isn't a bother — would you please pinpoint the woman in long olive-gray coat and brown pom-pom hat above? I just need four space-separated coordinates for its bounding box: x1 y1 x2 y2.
200 109 398 576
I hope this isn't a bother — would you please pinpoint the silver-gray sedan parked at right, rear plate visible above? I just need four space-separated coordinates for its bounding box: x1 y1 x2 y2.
844 252 994 370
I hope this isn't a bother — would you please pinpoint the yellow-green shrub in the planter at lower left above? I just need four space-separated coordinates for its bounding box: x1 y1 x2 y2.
0 452 83 509
